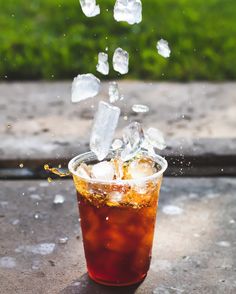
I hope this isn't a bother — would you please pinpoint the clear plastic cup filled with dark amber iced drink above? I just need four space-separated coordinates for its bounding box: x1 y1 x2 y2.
69 152 167 286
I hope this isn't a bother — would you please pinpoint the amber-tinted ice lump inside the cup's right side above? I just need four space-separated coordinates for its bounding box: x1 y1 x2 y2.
128 158 156 179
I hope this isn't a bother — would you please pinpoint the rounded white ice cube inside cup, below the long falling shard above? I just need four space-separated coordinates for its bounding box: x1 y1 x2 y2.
91 161 115 181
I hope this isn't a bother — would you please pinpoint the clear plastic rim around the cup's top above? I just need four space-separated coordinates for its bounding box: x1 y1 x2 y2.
68 151 168 185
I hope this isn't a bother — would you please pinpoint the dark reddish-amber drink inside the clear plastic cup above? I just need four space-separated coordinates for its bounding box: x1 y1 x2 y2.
74 179 160 286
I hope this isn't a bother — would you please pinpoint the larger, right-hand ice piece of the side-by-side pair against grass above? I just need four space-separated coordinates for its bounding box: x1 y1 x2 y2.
113 48 129 75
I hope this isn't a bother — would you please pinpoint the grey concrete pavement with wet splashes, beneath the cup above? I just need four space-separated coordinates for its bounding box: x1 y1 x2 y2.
0 178 236 294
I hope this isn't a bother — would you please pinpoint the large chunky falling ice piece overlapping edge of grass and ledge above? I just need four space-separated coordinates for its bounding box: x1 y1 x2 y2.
71 73 100 103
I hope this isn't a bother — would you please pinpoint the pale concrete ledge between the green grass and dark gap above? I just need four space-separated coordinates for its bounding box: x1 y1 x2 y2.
0 81 236 159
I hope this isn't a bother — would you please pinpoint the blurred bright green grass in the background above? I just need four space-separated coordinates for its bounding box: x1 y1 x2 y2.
0 0 236 81
